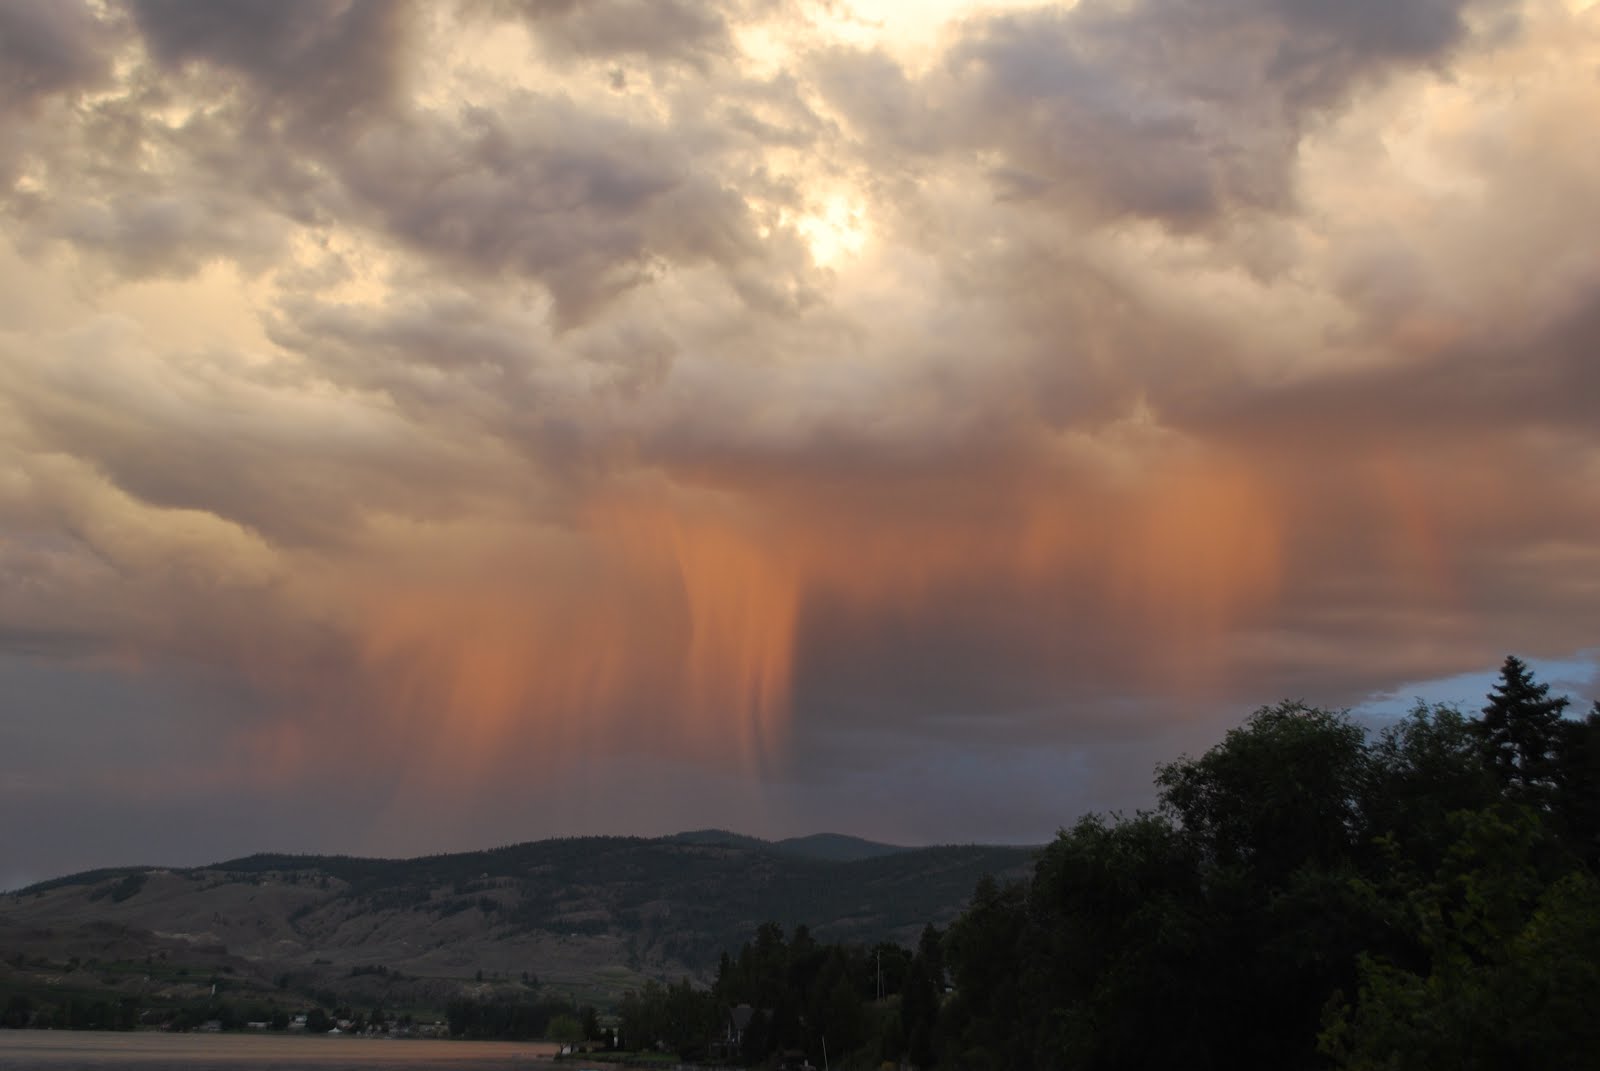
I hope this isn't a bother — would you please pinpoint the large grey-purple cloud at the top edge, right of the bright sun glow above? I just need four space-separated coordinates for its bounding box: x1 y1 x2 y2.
819 0 1523 229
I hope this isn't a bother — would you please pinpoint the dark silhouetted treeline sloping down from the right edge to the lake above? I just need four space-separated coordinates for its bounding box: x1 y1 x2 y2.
622 658 1600 1071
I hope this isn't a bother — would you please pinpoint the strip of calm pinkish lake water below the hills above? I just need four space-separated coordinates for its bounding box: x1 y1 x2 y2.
0 1029 557 1071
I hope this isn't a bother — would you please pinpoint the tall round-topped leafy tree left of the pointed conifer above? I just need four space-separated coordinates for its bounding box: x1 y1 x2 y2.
1152 703 1376 1066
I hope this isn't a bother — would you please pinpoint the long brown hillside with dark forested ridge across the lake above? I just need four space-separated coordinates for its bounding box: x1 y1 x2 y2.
0 831 1035 1005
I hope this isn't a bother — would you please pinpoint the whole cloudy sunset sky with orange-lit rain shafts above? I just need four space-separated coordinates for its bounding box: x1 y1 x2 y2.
0 0 1600 887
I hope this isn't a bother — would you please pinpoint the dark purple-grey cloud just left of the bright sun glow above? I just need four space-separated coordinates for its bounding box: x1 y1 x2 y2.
331 102 762 325
